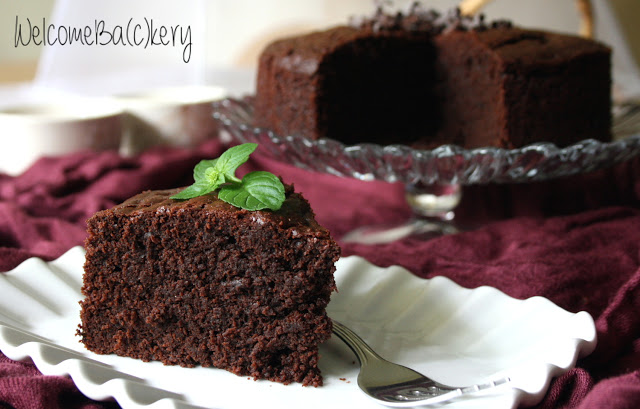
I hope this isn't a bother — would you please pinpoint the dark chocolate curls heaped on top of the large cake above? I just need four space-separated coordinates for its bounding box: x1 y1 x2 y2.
349 2 512 35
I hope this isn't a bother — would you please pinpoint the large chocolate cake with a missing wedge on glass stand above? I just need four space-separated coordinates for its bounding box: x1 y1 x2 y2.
255 6 611 148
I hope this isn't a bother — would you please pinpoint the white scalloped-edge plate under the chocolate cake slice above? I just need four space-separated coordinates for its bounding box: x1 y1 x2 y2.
0 247 596 409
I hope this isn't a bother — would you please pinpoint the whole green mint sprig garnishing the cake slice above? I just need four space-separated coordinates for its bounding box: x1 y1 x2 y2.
171 143 285 210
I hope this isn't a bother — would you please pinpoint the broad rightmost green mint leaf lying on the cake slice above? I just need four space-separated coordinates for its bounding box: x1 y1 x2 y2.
218 171 285 210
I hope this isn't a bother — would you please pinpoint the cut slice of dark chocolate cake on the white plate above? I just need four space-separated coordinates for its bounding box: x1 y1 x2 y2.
79 186 340 386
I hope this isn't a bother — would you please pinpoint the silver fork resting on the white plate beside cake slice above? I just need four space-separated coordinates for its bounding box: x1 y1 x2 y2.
333 320 511 407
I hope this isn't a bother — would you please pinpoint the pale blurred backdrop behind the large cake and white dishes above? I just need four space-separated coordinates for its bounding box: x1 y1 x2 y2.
0 0 640 90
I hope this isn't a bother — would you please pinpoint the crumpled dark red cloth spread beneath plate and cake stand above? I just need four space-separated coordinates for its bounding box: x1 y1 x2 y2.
0 141 640 409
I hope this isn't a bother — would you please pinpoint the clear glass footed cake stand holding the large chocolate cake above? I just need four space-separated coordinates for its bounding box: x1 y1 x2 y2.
213 97 640 244
